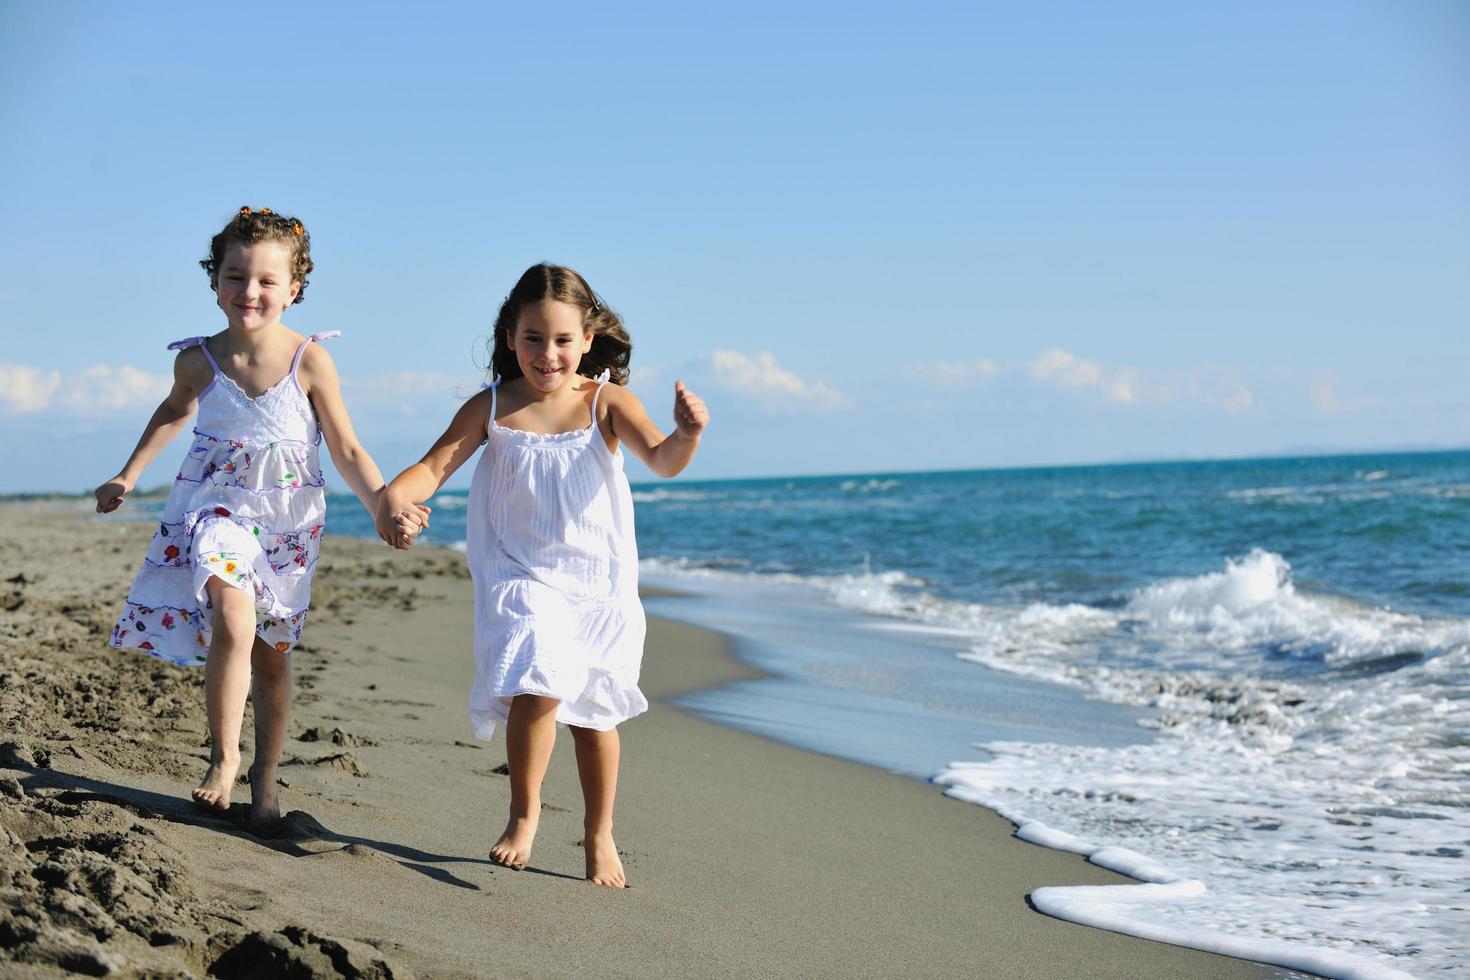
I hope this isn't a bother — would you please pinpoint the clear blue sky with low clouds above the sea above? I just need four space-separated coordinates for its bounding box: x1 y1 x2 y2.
0 0 1470 492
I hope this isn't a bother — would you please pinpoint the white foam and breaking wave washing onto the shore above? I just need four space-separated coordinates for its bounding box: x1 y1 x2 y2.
651 551 1470 977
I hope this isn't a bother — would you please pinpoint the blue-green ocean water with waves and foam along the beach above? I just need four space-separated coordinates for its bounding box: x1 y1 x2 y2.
332 453 1470 977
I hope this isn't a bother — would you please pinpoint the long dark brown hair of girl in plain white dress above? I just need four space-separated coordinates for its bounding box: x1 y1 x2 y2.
490 262 634 385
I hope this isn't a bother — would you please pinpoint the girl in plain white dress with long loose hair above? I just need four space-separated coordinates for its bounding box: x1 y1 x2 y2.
378 264 709 887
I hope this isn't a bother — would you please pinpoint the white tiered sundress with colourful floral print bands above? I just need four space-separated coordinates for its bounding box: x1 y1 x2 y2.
110 331 341 666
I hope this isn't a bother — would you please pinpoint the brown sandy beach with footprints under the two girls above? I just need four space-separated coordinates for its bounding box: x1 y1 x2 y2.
0 502 1279 977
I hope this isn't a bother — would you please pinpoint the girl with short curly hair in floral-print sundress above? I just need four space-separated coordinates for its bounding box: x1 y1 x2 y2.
97 207 420 824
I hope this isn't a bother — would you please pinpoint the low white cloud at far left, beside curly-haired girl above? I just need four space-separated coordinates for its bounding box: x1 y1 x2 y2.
0 364 171 416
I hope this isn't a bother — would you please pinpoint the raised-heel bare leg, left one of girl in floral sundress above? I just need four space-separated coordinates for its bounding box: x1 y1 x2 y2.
194 577 256 813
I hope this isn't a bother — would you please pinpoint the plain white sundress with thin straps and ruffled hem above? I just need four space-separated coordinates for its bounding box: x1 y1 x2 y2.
466 372 648 739
